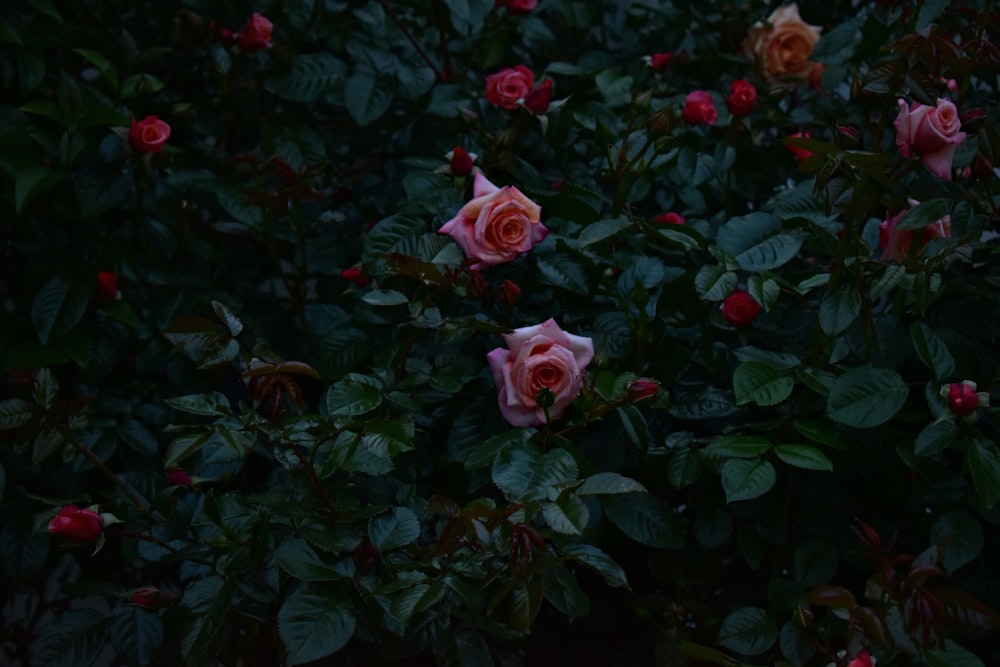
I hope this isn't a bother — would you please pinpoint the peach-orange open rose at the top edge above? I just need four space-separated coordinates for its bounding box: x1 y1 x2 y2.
744 2 822 83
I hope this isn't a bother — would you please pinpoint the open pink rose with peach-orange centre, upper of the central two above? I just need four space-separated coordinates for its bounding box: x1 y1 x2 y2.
438 171 549 269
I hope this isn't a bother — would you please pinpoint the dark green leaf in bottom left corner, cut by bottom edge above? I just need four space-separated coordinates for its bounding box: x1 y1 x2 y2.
31 608 106 667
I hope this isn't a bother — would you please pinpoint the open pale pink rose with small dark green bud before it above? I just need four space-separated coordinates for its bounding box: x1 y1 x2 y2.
487 319 594 426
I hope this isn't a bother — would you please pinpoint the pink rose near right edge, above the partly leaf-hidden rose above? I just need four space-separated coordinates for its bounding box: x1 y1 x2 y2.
893 99 965 181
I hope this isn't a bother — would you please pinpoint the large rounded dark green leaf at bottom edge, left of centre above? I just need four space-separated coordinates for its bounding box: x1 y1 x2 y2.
278 585 357 665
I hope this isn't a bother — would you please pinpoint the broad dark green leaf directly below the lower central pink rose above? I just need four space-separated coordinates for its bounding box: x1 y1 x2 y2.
493 441 579 503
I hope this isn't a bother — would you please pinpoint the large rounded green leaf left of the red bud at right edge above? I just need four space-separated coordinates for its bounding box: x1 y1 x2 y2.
826 366 910 428
